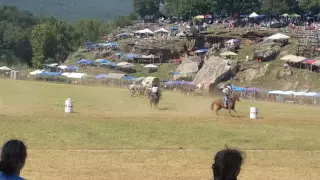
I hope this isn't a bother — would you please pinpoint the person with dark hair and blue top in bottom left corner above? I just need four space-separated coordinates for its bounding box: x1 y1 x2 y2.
0 140 27 180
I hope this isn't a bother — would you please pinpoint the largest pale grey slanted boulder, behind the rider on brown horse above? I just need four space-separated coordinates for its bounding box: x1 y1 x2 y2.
193 56 239 85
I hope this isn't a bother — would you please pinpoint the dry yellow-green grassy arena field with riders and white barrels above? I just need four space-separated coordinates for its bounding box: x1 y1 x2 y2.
0 80 320 180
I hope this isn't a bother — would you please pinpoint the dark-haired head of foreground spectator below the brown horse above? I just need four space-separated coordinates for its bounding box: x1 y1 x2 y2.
212 148 244 180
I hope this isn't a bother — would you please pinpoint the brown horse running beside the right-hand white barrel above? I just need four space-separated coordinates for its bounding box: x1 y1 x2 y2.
211 93 240 116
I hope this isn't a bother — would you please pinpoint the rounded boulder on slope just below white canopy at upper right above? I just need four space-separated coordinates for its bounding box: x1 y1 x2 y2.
253 43 280 61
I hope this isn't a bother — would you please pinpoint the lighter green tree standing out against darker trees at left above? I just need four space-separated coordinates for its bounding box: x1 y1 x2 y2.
31 24 53 68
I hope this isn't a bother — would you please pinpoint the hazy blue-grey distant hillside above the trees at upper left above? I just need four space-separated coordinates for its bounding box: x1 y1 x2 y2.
0 0 132 21
